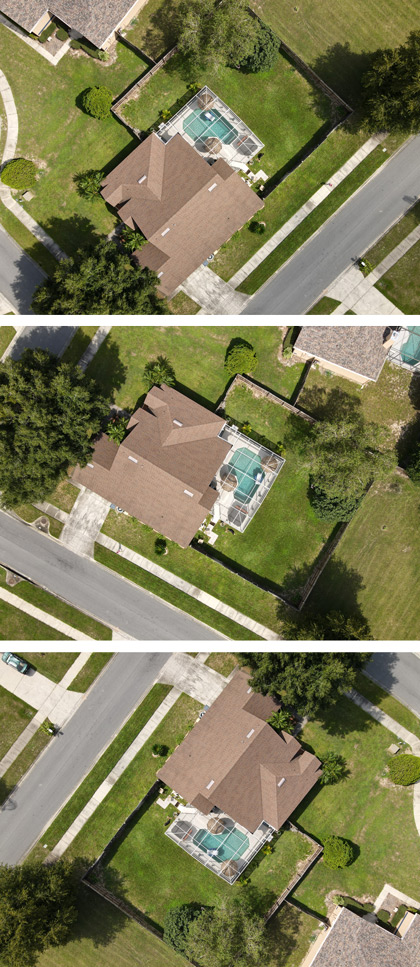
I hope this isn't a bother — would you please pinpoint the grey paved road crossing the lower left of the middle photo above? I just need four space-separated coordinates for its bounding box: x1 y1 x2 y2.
0 511 221 641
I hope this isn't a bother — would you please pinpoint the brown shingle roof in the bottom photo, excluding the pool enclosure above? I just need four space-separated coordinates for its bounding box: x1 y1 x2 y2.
158 672 321 832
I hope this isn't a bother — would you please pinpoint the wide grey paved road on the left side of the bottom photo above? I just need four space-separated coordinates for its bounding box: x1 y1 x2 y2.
0 652 168 864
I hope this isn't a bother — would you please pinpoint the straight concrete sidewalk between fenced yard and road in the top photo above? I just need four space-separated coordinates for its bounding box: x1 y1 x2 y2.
229 134 386 288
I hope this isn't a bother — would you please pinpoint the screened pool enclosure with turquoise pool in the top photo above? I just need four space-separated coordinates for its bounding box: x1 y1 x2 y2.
156 86 264 170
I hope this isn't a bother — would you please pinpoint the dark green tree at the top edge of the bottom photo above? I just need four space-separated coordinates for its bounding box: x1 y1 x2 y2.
239 651 370 715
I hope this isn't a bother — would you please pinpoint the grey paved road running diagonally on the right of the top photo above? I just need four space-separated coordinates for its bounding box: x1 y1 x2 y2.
244 135 420 315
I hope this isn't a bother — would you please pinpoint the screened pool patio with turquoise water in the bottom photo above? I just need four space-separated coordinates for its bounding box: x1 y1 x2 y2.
165 804 274 883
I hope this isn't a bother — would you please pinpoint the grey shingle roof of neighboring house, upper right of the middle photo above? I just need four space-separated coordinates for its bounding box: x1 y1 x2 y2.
294 326 387 380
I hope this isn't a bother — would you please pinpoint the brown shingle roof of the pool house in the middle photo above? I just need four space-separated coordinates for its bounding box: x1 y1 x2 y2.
73 385 230 547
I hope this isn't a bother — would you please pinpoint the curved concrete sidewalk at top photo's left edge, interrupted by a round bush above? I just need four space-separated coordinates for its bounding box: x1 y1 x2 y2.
0 70 67 259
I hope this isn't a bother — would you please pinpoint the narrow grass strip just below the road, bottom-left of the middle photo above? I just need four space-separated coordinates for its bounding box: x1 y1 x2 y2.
0 567 112 644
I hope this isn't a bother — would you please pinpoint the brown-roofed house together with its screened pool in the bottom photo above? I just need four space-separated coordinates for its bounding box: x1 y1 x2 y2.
157 671 321 882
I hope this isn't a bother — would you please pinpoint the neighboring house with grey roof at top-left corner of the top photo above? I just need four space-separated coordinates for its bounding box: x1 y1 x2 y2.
0 0 146 50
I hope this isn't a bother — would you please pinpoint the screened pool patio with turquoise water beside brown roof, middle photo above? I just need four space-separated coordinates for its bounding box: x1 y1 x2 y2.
212 424 285 532
